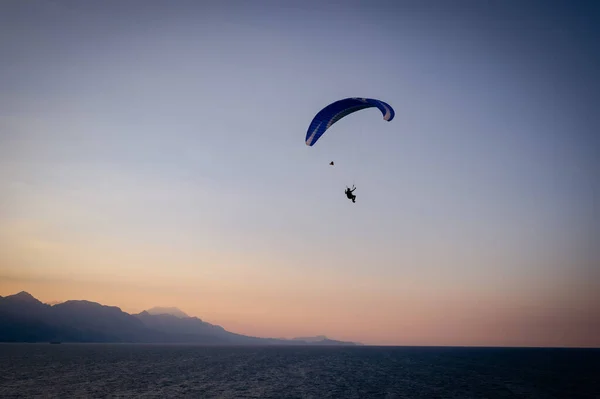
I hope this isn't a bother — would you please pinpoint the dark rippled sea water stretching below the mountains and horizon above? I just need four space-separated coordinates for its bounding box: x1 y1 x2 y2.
0 344 600 399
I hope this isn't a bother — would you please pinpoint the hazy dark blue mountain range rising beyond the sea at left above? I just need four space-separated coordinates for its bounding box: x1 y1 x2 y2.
0 291 358 345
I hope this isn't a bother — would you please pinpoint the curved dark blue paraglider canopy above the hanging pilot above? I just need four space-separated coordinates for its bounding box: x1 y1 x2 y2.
305 97 395 148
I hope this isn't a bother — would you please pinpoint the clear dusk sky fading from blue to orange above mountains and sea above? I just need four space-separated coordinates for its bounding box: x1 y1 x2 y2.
0 0 600 347
